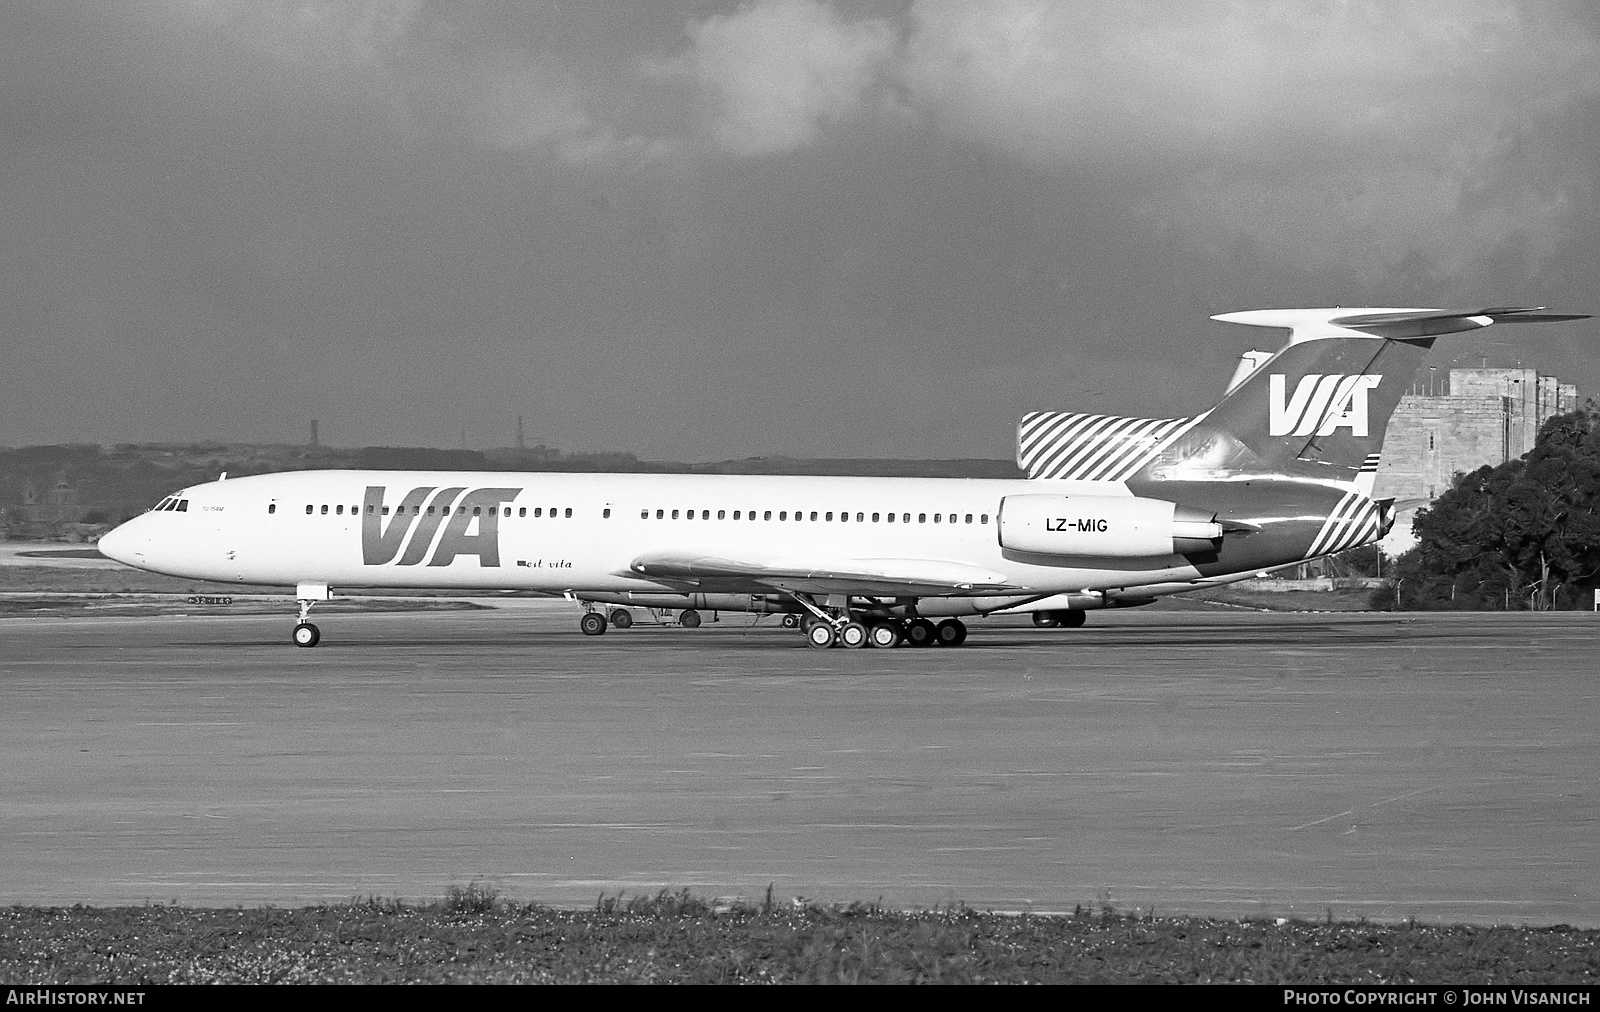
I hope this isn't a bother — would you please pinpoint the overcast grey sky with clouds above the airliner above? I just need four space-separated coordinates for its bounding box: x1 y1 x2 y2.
0 0 1600 460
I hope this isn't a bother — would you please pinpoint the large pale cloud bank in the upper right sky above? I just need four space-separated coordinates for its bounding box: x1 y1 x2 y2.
901 0 1600 277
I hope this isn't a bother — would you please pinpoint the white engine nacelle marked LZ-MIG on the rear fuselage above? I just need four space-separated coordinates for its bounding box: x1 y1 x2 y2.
998 495 1222 559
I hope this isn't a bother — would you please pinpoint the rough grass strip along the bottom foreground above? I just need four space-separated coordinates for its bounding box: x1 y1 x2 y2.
0 884 1600 985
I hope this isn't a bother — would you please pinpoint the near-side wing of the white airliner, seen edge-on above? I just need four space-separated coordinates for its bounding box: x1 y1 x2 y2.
629 552 1024 597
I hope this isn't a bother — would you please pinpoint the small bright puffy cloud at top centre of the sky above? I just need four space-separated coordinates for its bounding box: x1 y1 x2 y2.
658 0 899 157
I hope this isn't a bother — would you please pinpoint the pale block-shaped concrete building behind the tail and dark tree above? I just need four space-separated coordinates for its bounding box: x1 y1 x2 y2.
1373 367 1578 554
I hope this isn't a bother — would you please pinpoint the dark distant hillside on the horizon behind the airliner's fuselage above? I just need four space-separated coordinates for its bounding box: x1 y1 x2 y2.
0 444 1022 538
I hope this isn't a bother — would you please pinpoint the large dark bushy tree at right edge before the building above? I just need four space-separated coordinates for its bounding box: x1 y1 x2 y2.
1373 402 1600 610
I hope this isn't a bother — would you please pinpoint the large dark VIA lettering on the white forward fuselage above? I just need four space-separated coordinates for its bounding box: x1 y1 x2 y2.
362 485 522 568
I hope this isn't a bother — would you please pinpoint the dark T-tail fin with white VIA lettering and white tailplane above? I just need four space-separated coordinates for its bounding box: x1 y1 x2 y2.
1141 309 1584 485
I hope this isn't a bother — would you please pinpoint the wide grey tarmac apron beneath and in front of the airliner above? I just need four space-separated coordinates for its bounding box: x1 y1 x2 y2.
0 602 1600 926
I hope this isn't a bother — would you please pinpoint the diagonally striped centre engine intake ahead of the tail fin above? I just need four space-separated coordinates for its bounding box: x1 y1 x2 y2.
1016 412 1200 482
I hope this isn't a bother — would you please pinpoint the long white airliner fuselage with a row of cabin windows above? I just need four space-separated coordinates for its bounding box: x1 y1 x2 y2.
101 471 1211 610
